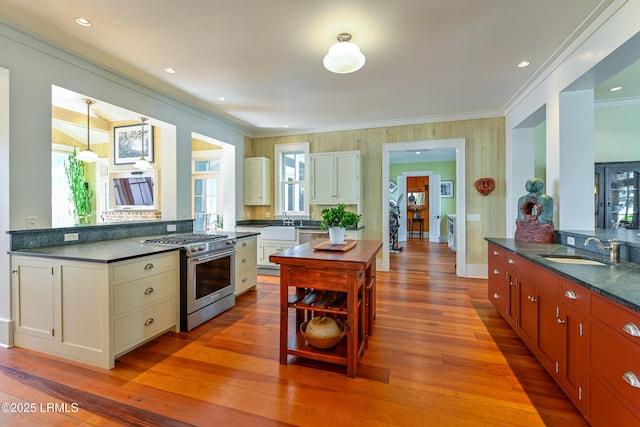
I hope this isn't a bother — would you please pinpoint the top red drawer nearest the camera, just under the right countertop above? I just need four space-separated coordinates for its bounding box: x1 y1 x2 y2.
591 294 640 351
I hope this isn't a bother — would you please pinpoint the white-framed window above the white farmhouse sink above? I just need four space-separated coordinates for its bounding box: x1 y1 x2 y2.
275 142 309 215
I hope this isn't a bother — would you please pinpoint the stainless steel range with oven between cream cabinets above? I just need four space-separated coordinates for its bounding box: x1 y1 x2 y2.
144 234 236 331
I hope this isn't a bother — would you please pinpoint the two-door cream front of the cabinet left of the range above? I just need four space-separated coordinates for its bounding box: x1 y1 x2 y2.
12 256 109 367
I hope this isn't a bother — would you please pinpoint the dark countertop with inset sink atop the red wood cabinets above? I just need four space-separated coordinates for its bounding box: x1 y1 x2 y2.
485 237 640 312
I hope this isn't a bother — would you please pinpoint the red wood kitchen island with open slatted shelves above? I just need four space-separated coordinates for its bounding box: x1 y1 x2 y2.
269 240 382 378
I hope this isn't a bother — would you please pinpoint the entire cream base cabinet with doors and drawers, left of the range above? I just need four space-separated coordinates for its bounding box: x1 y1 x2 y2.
11 251 180 369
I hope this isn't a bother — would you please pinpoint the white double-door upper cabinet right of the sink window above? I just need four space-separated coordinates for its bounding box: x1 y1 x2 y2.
310 151 361 205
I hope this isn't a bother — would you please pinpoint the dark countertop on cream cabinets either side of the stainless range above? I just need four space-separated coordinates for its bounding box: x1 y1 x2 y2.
9 231 259 263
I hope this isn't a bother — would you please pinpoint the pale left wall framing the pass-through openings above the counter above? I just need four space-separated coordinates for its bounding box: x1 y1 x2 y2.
0 25 247 345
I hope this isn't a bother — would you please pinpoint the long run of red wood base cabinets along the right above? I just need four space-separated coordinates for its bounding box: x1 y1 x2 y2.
488 244 640 427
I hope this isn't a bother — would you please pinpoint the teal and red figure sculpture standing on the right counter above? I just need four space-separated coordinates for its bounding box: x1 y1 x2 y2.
515 178 554 243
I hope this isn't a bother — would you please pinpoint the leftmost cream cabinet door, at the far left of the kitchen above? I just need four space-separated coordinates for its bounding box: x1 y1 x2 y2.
12 257 55 340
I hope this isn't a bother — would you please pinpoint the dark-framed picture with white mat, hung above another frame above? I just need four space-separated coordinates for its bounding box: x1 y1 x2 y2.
113 125 153 165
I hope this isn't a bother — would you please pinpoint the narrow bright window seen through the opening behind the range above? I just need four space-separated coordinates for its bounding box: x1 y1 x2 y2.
192 150 222 231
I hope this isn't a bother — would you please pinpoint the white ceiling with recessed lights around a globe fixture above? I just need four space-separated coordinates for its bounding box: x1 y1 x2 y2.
0 0 632 136
